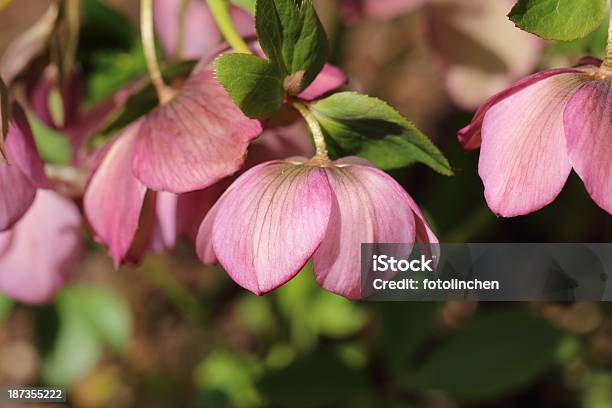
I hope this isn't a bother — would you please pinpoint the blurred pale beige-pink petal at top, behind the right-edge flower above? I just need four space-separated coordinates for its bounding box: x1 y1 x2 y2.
428 0 544 110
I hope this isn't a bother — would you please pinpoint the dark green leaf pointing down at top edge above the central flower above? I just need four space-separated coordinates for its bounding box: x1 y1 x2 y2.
255 0 329 91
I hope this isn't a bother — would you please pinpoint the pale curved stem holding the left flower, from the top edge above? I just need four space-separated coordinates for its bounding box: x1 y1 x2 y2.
140 0 174 105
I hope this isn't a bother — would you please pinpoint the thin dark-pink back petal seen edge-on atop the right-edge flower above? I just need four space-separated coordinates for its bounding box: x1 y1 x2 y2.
458 68 581 150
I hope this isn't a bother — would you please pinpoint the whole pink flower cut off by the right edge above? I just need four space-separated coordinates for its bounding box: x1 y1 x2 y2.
459 59 612 217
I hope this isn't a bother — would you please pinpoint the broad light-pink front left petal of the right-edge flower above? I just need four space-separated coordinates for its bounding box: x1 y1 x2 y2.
479 73 588 217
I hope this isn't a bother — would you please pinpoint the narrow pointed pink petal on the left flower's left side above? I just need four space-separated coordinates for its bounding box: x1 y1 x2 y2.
83 122 147 264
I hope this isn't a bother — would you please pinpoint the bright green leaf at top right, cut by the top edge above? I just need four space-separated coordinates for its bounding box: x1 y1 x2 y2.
508 0 606 41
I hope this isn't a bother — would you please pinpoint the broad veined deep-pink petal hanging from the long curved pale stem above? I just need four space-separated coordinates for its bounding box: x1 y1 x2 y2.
133 67 262 193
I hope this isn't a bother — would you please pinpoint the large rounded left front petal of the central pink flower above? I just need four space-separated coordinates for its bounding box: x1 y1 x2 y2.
207 162 331 295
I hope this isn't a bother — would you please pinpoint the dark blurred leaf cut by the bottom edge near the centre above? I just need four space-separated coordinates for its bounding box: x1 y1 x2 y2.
258 352 366 407
